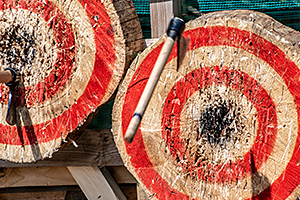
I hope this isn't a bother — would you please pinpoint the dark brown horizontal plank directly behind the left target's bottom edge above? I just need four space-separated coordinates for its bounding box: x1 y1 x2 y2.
0 129 123 167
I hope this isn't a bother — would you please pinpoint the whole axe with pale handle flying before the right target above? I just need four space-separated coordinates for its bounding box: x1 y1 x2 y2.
125 17 189 143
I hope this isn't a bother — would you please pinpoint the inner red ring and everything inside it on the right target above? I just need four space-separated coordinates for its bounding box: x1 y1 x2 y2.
162 67 277 182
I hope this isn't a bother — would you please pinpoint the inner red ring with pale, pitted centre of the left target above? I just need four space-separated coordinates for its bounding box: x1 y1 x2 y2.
0 2 76 107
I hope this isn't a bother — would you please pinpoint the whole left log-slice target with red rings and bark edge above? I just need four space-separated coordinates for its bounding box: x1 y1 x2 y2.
0 0 143 162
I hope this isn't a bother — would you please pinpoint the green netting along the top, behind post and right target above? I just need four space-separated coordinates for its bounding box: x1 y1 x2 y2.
132 0 300 38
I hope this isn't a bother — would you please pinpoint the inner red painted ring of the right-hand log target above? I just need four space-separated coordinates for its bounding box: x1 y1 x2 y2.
162 67 277 182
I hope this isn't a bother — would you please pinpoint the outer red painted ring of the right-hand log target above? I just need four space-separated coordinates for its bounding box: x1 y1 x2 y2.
122 26 300 199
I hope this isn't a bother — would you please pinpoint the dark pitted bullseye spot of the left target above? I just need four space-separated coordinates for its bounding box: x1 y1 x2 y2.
0 26 36 69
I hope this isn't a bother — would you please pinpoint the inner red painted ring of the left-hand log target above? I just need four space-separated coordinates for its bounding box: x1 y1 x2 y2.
0 1 75 106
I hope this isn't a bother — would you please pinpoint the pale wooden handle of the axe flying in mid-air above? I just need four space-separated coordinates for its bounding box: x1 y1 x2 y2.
125 37 175 143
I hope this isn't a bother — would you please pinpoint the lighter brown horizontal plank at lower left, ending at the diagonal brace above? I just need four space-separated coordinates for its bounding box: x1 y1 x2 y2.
0 167 77 188
